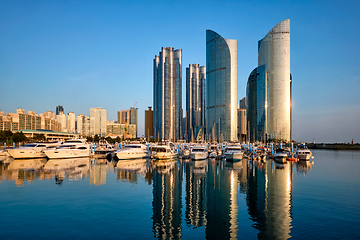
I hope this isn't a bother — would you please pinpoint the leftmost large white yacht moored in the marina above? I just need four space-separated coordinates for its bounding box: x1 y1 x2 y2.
7 142 61 159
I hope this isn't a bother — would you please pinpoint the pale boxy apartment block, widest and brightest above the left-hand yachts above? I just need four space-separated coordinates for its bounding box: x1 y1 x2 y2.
90 108 107 137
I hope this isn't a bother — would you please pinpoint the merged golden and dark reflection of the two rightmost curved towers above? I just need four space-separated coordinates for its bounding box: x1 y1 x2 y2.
246 161 292 239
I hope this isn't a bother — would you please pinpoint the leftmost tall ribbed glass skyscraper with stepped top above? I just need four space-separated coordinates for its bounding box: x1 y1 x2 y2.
154 47 182 140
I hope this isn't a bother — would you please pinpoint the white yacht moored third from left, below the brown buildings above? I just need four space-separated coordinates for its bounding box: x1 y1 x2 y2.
115 143 151 159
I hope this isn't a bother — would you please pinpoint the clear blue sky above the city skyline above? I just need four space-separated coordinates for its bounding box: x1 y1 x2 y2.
0 0 360 142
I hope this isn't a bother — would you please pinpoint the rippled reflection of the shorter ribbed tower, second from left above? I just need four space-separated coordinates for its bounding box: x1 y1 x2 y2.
184 160 208 228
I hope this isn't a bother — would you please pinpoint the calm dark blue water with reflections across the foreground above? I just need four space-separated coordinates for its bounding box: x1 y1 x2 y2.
0 150 360 239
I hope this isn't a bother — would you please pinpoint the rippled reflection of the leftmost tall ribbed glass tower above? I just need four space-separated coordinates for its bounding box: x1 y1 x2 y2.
152 160 182 239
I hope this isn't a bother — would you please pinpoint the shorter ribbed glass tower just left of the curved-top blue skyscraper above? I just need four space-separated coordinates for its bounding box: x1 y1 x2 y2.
184 64 206 139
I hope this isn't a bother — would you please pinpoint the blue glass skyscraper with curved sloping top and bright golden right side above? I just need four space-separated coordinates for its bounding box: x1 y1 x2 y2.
206 30 238 140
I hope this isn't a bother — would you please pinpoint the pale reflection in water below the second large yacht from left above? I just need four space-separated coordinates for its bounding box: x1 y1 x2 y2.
42 157 90 184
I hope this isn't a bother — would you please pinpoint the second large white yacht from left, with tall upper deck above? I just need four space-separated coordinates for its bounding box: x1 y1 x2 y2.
43 139 90 159
